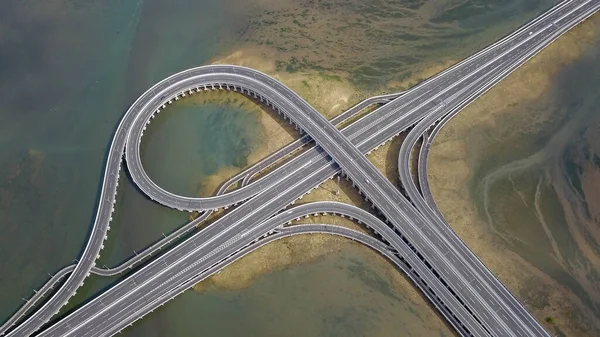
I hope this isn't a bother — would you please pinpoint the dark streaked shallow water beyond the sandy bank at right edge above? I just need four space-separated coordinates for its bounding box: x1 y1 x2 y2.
471 26 600 333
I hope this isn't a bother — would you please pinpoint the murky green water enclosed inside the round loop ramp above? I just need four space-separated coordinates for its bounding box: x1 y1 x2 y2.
142 100 261 196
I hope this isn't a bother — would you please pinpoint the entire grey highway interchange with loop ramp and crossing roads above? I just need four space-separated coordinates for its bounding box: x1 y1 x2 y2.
0 0 600 336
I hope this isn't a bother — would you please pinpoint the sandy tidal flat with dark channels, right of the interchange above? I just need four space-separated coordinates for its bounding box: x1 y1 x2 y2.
429 15 600 336
